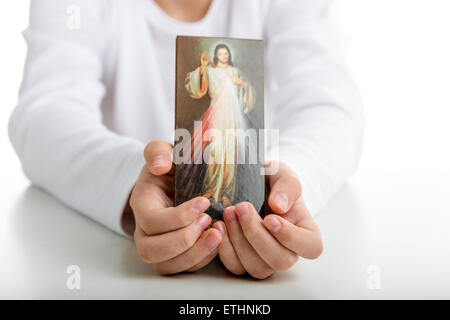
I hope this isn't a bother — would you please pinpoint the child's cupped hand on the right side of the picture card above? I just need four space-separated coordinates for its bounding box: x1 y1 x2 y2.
214 163 323 279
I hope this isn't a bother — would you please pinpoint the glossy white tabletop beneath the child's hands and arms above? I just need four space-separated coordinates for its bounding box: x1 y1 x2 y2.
0 168 450 299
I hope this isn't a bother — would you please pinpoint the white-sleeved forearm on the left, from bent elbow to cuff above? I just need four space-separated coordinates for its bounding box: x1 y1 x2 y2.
10 96 143 233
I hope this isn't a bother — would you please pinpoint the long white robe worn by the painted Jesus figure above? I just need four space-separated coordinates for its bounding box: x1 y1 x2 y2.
186 65 253 202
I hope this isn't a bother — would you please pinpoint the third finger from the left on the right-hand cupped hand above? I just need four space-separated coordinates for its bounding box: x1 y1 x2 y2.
235 202 298 271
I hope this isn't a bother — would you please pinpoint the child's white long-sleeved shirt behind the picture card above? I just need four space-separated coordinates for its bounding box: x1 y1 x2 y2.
9 0 363 234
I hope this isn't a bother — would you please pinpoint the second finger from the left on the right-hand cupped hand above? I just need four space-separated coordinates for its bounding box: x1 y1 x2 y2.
223 206 273 279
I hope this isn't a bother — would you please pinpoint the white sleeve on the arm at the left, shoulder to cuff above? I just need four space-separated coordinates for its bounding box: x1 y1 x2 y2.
9 0 144 234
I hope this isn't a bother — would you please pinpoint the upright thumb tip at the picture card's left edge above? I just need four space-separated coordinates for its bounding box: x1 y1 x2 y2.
144 140 173 176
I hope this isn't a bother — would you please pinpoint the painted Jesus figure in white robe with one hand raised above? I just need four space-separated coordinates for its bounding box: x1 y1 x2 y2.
185 44 255 212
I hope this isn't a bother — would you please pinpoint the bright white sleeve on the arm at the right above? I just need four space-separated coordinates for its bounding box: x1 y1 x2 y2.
265 0 364 215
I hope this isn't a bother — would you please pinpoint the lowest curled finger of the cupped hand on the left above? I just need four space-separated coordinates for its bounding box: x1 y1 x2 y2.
154 229 222 274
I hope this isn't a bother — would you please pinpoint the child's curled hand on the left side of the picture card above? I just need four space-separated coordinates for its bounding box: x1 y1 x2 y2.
130 141 222 274
